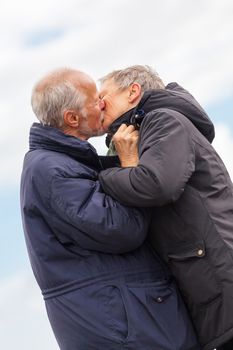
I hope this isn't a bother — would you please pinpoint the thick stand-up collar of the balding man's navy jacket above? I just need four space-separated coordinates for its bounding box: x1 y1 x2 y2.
29 123 100 168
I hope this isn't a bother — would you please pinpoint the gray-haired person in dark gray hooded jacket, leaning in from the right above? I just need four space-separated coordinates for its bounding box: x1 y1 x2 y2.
100 66 233 350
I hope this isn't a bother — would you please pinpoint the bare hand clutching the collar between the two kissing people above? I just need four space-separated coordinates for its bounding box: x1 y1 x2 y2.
112 124 139 168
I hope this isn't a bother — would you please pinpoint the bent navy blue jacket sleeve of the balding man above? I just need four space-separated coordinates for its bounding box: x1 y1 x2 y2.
50 176 150 254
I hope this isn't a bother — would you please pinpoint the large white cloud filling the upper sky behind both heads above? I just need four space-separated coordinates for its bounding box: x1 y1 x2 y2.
0 0 233 189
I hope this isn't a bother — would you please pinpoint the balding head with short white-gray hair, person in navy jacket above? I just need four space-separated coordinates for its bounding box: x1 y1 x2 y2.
31 68 85 128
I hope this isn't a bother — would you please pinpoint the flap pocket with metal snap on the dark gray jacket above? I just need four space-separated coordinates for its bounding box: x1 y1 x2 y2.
168 241 221 306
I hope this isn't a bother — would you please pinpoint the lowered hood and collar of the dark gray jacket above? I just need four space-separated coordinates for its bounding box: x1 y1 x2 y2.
106 83 215 144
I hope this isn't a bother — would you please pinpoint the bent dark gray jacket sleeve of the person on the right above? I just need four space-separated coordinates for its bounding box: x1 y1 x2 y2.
99 109 195 207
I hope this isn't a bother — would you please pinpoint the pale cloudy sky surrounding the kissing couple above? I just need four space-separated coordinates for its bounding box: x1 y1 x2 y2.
0 0 233 350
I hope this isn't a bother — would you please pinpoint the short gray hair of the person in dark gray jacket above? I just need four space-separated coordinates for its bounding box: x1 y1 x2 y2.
100 65 165 93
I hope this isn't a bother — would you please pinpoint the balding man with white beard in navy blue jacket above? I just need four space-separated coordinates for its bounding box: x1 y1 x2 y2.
21 69 200 350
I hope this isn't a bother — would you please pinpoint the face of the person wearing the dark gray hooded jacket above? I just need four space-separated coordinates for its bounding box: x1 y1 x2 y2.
99 79 131 132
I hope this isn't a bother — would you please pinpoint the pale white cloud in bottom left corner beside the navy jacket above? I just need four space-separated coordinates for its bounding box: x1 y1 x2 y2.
0 271 59 350
